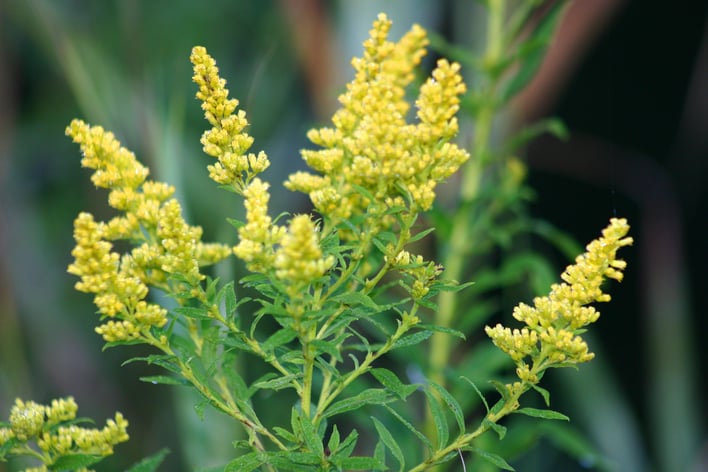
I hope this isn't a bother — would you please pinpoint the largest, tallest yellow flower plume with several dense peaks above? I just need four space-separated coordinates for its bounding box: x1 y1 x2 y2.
285 14 469 218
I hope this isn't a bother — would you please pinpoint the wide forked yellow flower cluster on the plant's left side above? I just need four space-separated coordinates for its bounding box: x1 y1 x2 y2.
66 120 231 342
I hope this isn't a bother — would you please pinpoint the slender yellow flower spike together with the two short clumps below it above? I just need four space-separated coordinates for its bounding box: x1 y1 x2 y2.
190 46 334 284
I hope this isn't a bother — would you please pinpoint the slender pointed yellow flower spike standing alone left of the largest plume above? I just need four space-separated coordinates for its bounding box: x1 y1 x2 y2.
190 46 270 193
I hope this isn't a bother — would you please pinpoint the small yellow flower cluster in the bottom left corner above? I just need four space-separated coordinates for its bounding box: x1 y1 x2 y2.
0 397 128 470
